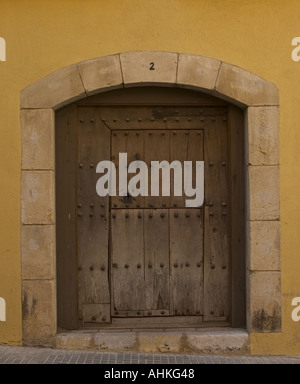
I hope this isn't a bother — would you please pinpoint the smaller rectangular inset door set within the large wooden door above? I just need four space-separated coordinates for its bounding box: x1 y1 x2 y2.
111 127 203 317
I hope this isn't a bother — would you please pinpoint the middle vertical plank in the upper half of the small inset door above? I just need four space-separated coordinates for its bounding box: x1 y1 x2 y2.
145 130 171 208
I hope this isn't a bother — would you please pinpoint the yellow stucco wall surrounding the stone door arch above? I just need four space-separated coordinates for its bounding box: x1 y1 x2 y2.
0 0 300 355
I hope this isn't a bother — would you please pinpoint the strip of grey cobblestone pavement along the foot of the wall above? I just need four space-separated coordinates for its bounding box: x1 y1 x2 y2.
0 346 300 365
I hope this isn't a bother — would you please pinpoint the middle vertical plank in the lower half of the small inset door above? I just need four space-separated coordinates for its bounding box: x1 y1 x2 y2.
144 209 170 316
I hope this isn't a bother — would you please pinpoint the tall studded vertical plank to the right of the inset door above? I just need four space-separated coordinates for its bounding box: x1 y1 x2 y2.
204 116 231 321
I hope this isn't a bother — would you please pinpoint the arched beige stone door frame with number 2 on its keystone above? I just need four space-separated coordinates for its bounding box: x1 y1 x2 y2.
21 51 281 344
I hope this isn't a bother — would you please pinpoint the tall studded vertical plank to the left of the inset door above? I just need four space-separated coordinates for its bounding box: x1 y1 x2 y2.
77 107 110 322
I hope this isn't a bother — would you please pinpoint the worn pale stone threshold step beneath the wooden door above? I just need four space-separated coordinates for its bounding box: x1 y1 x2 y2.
52 328 250 355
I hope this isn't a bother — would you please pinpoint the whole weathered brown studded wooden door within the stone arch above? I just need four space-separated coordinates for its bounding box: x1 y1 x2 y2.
58 88 243 328
